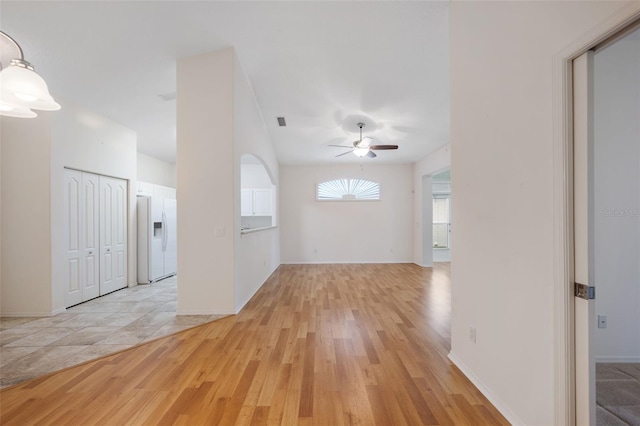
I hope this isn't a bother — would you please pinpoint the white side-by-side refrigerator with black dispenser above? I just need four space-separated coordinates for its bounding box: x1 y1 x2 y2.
137 197 178 284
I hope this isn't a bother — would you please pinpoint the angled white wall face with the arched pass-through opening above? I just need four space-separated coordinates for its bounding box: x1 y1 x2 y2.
233 55 280 312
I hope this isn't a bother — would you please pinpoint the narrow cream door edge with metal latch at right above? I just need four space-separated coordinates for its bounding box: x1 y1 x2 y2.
573 51 596 425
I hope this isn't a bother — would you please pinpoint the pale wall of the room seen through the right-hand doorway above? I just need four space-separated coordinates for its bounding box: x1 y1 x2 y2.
594 32 640 362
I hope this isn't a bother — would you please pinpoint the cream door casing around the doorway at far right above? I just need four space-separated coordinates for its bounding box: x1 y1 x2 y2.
553 2 640 425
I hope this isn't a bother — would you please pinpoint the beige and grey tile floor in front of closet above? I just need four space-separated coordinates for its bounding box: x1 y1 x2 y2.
0 277 224 388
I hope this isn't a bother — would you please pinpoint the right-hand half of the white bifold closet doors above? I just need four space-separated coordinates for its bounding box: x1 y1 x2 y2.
100 176 128 296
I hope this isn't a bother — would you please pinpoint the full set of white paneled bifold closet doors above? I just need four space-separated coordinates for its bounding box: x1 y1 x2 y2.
63 169 127 307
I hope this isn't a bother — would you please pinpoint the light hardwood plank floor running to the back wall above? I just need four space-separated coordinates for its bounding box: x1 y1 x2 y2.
0 264 508 425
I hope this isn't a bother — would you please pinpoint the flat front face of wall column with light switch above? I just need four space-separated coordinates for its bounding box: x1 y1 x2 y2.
177 49 235 315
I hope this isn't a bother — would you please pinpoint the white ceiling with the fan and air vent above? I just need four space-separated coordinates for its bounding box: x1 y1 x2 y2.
0 0 449 164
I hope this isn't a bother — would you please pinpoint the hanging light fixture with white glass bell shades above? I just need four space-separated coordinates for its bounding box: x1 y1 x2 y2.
0 31 60 118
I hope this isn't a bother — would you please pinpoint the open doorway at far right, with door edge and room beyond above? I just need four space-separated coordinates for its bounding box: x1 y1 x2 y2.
571 17 640 425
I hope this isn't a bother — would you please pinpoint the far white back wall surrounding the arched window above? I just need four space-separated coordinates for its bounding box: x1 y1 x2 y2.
280 160 413 263
